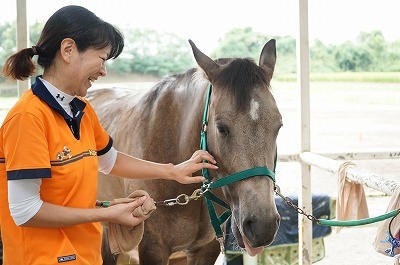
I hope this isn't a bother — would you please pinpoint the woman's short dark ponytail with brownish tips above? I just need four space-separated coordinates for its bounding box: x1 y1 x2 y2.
3 46 38 80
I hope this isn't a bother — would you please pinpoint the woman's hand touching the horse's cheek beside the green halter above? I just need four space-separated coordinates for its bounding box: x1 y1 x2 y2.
173 150 218 184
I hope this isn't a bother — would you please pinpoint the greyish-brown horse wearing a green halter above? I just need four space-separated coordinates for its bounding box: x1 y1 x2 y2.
88 39 282 265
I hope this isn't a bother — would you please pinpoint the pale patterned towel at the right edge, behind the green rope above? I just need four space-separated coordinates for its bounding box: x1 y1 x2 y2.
373 188 400 256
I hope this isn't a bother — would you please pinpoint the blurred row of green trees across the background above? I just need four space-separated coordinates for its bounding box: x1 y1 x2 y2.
0 21 400 78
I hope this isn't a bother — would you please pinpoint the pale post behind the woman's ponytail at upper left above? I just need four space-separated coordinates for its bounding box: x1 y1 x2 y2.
17 0 31 97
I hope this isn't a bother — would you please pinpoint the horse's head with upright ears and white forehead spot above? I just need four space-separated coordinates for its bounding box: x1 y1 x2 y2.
190 40 282 255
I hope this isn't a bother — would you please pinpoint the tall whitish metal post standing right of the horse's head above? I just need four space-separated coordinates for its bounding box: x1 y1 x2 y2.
296 0 312 265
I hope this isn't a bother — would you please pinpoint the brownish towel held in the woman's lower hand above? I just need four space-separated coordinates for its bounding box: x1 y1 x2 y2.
107 190 156 255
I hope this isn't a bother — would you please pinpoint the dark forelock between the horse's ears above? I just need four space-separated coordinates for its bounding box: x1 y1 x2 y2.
215 58 269 109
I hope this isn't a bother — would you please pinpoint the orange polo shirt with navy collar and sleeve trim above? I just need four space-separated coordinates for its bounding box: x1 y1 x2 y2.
0 75 112 265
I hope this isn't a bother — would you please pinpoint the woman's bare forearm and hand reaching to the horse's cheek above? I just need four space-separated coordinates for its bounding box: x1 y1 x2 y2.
110 150 218 184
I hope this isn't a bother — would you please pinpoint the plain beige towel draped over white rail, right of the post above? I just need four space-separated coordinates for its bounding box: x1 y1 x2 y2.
336 162 369 232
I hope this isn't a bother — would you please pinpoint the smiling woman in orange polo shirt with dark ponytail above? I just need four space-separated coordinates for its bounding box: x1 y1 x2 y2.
0 6 217 265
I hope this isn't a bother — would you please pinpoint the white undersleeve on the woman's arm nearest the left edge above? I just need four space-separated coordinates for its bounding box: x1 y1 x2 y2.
7 179 43 226
